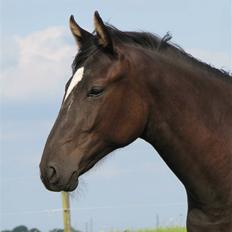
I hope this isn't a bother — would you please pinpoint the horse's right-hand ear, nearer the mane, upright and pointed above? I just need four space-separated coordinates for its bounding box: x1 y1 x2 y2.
94 11 114 53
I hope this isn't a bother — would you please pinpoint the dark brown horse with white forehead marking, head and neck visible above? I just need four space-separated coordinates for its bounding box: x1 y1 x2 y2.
40 12 232 232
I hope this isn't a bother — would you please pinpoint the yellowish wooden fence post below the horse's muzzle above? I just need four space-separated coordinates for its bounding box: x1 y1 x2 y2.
61 192 71 232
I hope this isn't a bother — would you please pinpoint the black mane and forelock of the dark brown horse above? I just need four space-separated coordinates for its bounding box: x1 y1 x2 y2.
72 24 232 81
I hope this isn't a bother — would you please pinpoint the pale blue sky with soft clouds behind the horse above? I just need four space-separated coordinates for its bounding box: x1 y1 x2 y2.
0 0 232 232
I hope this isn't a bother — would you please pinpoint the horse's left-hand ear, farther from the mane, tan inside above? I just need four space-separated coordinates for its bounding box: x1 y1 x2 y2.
69 15 93 48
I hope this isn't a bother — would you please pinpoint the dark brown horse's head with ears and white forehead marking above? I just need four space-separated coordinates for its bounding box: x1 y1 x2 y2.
40 12 149 191
